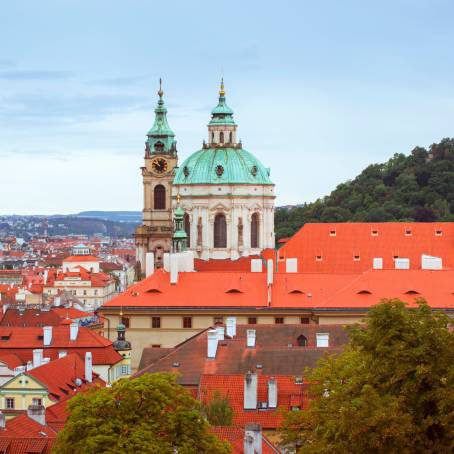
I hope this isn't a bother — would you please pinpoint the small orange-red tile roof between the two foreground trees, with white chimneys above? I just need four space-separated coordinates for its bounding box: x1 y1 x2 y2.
198 375 308 429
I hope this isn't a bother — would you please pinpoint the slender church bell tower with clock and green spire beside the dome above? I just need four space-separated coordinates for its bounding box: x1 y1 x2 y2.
134 79 178 277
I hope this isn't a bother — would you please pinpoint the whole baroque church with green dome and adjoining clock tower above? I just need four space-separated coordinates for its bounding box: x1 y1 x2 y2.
135 83 275 276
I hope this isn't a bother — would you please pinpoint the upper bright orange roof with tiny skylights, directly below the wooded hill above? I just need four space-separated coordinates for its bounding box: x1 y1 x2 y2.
278 222 454 273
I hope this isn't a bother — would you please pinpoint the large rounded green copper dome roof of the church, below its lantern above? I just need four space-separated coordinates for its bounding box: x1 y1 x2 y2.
173 148 273 184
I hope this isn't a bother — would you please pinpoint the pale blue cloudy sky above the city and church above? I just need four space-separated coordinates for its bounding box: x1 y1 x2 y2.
0 0 454 214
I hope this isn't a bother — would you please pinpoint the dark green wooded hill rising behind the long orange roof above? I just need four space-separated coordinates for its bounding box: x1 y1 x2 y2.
275 139 454 239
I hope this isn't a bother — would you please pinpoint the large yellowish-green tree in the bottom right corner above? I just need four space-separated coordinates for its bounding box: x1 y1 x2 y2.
282 300 454 454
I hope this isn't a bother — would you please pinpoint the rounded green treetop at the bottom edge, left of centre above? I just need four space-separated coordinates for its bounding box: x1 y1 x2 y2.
53 373 231 454
